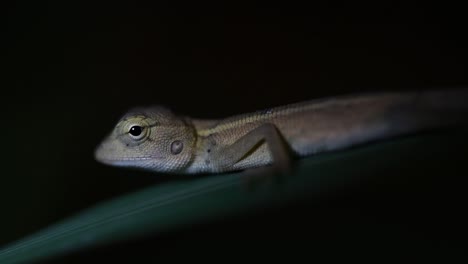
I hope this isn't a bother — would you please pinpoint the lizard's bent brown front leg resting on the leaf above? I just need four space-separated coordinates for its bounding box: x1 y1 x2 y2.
213 123 291 172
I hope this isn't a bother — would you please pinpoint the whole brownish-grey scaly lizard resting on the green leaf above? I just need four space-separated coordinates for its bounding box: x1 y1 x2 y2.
94 89 468 174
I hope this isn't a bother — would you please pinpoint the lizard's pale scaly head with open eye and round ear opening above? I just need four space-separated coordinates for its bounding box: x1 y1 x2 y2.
95 107 196 172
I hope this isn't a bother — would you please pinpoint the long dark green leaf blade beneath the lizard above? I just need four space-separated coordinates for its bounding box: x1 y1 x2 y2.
0 132 466 264
